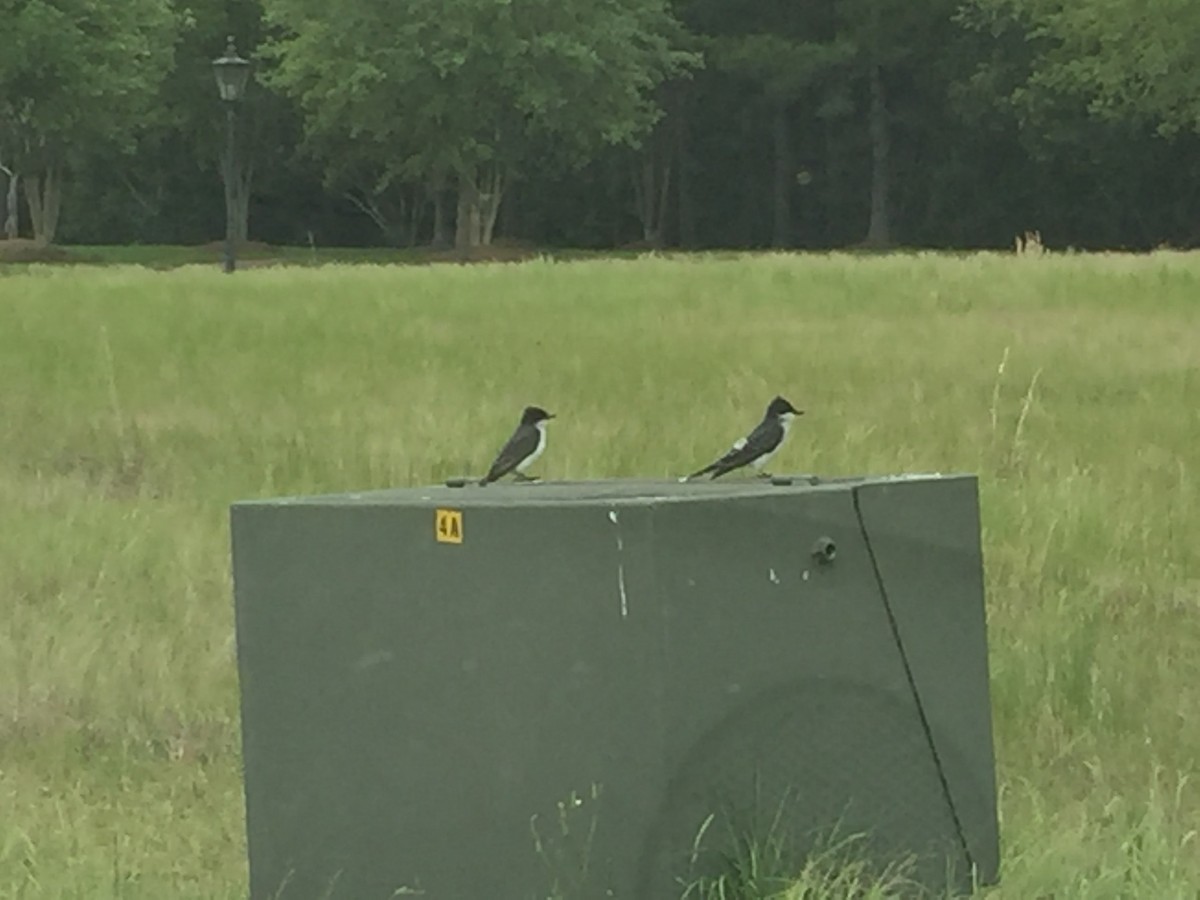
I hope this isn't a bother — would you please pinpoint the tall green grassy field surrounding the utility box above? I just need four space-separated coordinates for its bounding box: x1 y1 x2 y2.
0 253 1200 900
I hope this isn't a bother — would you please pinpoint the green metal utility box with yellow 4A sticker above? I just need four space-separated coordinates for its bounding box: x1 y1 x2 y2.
232 475 998 900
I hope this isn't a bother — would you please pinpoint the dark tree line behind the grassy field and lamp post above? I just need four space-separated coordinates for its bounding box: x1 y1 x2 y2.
0 0 1200 250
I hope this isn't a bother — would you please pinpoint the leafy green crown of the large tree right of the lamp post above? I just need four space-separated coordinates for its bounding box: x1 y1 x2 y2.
258 0 696 188
